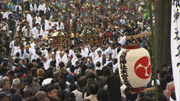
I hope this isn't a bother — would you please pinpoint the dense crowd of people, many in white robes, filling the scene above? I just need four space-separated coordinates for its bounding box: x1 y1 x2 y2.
0 0 174 101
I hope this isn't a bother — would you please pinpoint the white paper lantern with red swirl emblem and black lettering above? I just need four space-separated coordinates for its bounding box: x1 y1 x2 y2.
118 47 151 92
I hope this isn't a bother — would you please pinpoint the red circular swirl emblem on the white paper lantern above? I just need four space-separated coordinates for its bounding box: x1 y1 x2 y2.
134 56 151 79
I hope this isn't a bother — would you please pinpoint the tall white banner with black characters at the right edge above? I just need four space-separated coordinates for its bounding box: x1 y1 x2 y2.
171 0 180 101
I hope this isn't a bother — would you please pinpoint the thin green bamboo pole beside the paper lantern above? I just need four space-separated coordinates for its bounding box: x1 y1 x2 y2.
149 0 158 101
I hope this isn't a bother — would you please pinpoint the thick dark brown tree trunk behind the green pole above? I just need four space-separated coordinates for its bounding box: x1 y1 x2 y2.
155 0 171 68
